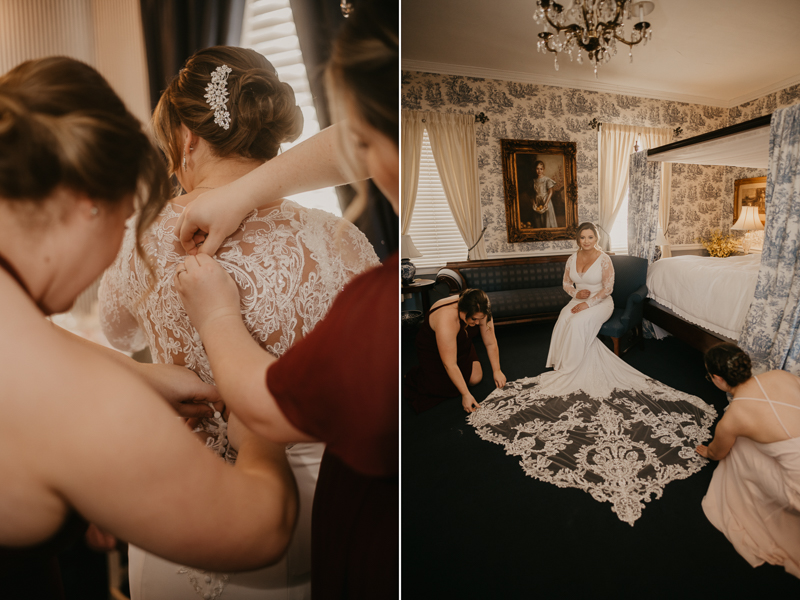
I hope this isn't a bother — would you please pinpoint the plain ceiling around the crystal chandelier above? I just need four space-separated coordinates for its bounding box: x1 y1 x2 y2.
401 0 800 107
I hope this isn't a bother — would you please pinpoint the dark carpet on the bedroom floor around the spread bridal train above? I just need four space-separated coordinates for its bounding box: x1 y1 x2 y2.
401 322 800 599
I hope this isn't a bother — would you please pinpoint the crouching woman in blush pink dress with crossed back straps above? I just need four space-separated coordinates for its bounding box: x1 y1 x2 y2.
697 343 800 577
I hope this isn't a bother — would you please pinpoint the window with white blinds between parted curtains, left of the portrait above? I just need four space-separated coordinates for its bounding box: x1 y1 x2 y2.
408 131 467 269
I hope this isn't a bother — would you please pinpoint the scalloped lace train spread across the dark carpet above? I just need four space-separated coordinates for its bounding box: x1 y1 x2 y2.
468 380 716 526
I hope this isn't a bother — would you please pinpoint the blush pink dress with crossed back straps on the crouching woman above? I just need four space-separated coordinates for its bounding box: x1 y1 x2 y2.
703 377 800 577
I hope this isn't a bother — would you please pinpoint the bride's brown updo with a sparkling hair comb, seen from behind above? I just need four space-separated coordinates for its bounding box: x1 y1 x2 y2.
153 46 303 173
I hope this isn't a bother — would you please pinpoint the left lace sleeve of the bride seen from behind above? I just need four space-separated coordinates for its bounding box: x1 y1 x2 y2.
97 228 147 352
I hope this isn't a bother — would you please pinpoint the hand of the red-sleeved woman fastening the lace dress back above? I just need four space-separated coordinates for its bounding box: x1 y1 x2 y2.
175 253 242 337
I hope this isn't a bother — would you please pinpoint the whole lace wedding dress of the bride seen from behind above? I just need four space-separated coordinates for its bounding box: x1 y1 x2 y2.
99 200 378 600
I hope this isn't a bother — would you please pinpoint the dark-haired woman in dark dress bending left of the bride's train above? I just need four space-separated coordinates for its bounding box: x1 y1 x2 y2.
403 289 506 412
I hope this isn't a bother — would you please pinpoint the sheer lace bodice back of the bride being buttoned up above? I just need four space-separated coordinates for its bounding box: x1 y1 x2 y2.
99 200 378 438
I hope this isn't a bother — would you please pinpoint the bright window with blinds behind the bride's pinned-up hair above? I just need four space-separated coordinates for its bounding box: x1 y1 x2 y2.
242 0 342 216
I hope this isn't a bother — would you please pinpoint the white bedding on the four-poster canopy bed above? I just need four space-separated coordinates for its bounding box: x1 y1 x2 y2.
647 254 761 340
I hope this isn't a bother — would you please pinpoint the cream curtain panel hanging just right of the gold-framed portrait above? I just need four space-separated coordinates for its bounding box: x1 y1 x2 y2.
597 123 640 250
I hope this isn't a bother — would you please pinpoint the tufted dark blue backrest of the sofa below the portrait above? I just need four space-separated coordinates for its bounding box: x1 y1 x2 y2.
459 262 566 295
